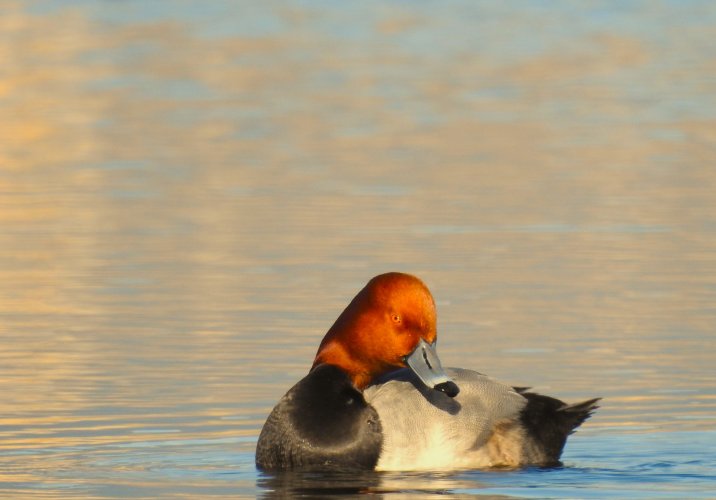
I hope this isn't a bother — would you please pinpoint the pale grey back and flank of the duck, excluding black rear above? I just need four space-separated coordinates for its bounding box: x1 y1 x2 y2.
364 368 527 470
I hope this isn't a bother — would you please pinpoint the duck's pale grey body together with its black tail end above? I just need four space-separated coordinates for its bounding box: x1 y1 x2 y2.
364 368 599 470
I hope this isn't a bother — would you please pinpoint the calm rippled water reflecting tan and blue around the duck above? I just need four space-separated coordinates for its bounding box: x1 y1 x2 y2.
0 0 716 498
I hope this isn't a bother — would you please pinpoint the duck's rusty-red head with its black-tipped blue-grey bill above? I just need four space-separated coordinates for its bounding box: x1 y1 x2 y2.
313 273 458 396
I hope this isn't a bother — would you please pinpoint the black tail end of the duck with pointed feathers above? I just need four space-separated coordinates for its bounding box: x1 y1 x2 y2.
519 391 601 465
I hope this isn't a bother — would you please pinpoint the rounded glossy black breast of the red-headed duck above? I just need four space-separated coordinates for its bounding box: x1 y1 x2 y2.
256 364 383 470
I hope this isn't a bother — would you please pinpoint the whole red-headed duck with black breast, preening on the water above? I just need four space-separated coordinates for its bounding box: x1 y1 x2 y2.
255 272 600 471
